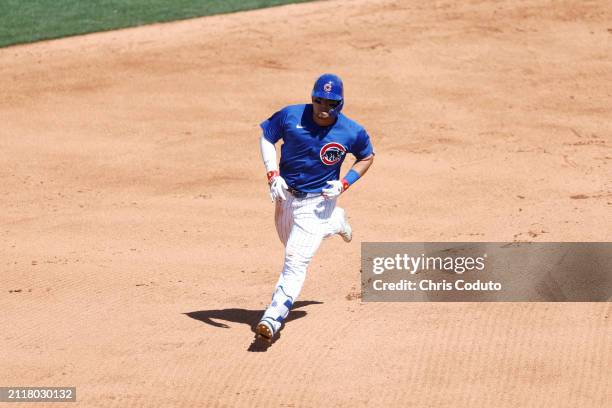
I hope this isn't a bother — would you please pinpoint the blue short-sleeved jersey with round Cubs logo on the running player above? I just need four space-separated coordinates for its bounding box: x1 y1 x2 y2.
260 104 374 193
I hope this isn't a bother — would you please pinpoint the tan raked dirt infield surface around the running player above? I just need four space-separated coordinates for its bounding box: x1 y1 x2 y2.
0 0 612 407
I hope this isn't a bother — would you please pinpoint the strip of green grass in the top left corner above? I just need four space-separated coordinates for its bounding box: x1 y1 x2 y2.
0 0 316 47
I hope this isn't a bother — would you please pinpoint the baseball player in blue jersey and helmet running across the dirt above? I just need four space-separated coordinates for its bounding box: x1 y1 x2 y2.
255 74 374 341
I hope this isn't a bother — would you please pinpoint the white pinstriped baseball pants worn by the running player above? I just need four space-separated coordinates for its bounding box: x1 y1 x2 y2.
262 192 342 331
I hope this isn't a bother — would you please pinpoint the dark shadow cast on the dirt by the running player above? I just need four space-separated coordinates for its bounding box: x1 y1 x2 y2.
185 300 323 351
